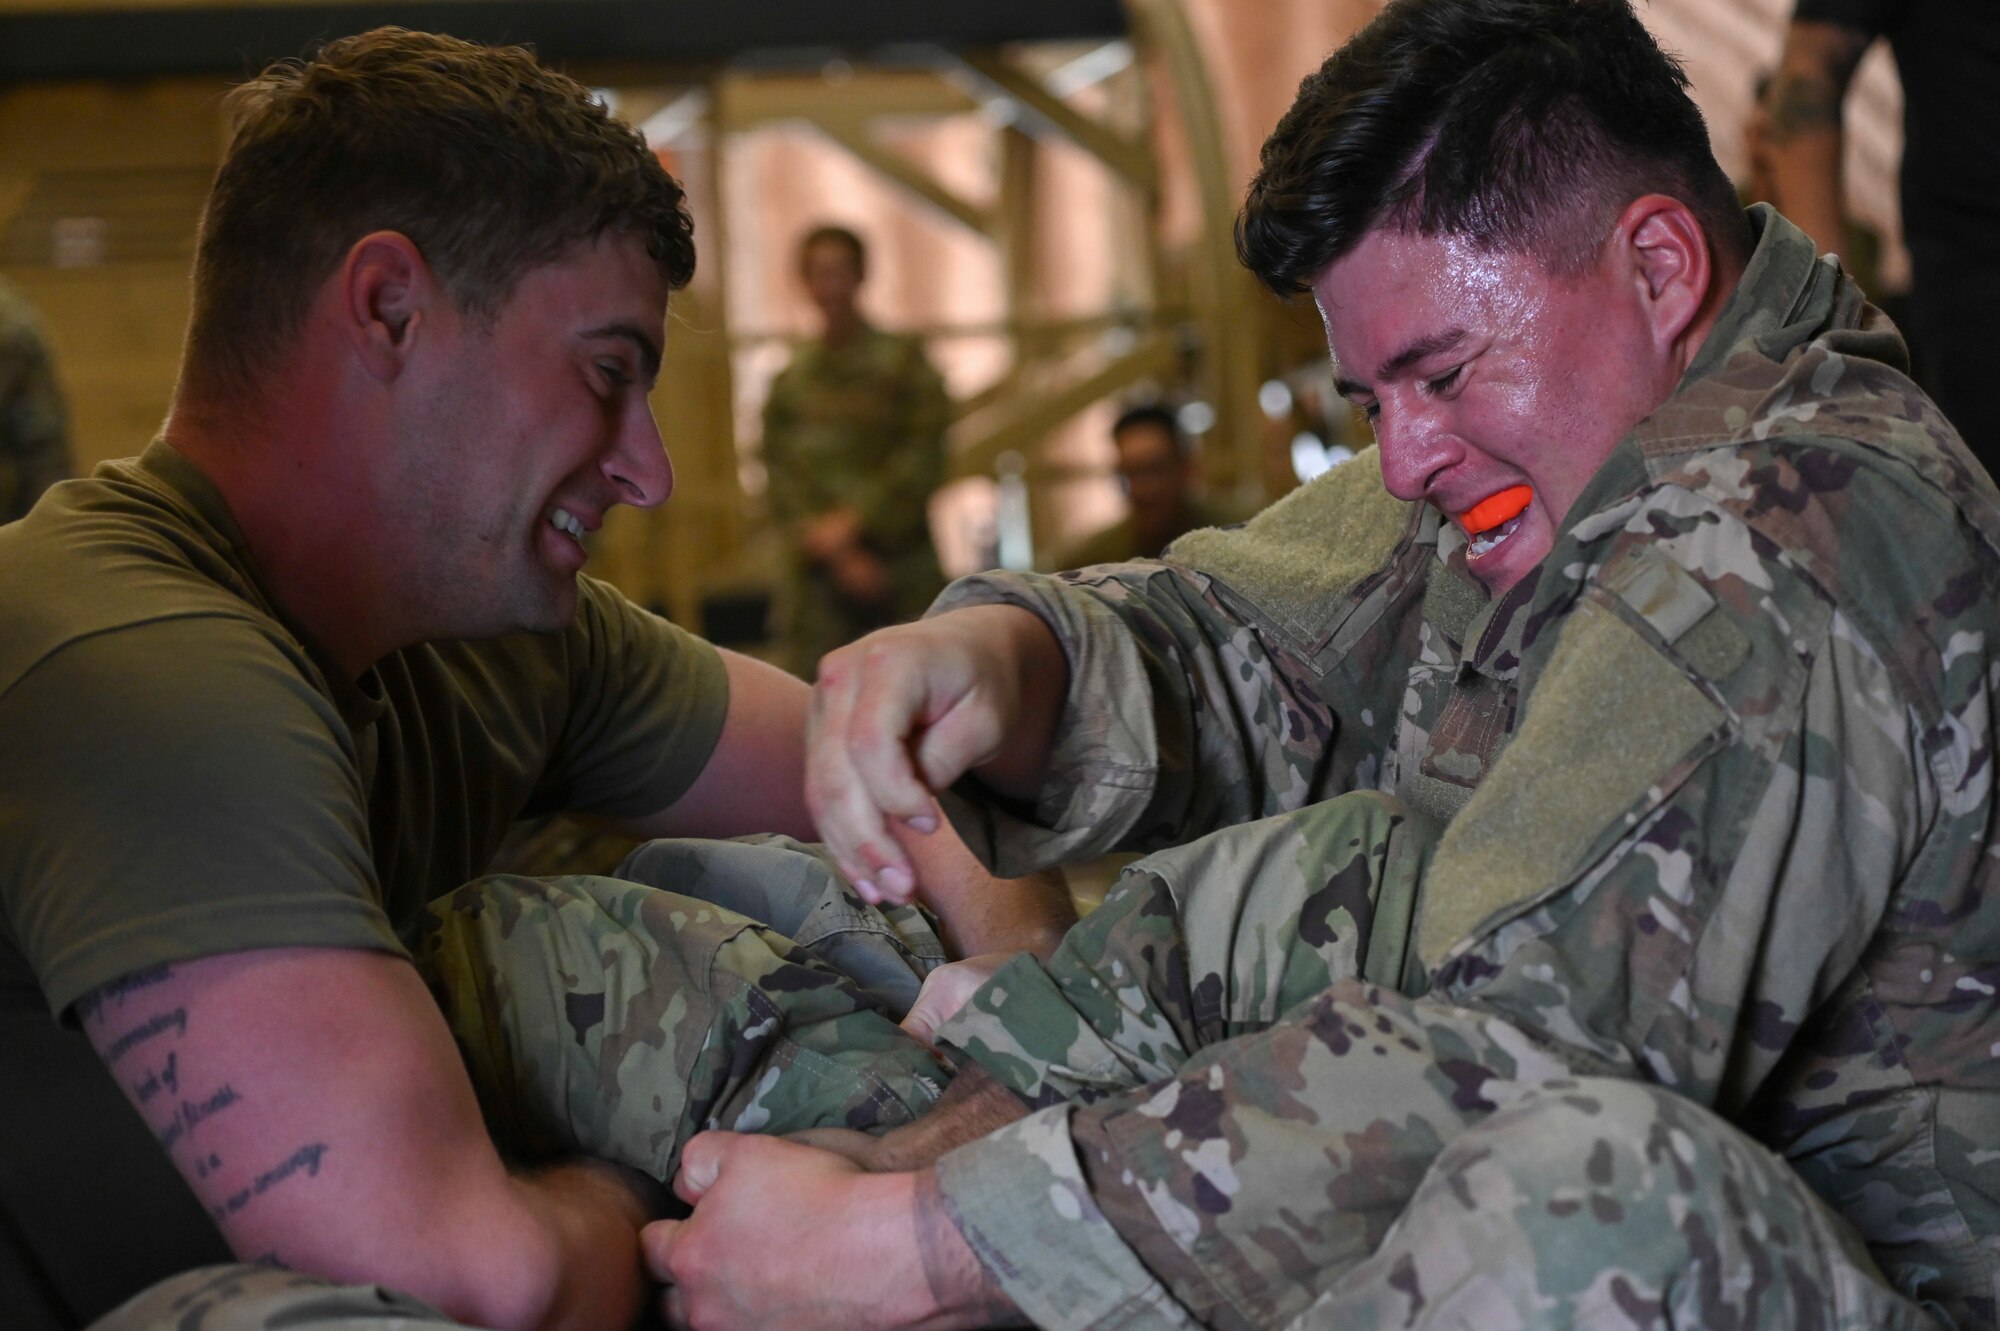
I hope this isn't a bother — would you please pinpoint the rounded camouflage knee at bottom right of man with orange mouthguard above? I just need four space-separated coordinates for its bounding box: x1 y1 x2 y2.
1292 1077 1940 1331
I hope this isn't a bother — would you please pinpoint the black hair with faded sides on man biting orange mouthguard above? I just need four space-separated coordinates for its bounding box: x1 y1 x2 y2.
1236 0 1750 296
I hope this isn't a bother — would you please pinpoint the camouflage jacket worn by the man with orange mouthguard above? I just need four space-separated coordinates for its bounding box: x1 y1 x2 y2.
938 208 2000 1325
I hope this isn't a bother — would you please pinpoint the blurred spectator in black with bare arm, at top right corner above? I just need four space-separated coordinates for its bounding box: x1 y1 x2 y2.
1768 0 2000 472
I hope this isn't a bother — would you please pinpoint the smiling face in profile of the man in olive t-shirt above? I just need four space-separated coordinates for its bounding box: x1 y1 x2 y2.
384 234 674 638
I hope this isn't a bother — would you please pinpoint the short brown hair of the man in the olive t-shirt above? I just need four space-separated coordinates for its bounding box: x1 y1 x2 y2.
186 28 694 396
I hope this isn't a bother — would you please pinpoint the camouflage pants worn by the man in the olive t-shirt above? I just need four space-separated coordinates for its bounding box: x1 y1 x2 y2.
92 837 950 1331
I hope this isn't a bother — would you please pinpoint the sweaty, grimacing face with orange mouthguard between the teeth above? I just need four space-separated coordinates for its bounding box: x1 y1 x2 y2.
1312 230 1674 596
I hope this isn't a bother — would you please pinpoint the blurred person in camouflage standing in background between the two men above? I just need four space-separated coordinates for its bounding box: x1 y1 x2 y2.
764 226 952 679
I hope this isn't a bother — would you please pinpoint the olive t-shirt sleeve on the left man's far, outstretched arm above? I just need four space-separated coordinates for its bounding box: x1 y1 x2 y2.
526 578 730 817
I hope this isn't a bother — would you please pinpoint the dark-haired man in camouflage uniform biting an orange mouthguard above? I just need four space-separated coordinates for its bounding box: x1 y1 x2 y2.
648 0 2000 1329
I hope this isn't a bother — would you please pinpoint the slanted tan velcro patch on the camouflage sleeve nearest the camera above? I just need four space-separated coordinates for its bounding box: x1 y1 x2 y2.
1418 598 1728 969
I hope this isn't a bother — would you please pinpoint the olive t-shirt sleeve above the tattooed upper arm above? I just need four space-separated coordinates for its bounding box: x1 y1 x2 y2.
0 616 402 1013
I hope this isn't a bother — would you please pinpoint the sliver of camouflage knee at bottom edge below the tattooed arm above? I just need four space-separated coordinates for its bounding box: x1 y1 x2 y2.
90 1265 458 1331
